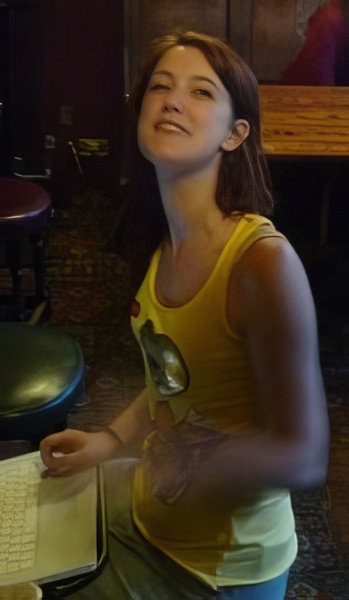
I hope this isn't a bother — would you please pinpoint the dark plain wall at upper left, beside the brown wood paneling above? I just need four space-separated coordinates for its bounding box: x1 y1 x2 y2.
0 0 124 190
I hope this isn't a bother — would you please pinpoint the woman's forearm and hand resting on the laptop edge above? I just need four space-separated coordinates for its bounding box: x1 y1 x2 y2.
40 390 153 477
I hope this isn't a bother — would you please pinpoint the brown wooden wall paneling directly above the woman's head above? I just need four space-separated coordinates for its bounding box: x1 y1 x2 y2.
125 0 327 89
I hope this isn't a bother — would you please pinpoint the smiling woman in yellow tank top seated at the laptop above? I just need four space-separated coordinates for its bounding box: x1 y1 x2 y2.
41 32 329 600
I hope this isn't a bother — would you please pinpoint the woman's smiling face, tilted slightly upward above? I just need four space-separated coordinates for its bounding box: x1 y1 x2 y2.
138 46 234 173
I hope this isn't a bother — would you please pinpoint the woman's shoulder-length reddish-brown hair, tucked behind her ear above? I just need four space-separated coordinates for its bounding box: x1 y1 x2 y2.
134 30 274 216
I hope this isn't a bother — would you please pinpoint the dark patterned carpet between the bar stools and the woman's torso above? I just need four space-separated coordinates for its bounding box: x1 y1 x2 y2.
47 190 144 431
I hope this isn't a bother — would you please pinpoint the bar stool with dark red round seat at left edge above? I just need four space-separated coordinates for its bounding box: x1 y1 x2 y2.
0 178 52 320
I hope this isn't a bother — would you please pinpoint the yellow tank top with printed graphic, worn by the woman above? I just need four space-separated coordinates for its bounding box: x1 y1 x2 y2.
131 214 297 589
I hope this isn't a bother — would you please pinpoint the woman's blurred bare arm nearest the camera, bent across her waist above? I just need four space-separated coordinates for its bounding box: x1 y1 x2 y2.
188 238 329 501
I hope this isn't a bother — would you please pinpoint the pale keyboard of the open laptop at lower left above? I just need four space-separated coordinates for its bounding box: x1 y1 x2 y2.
0 457 41 575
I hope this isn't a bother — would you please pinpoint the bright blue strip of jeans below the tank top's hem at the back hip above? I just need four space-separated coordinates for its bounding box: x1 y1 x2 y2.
217 571 289 600
